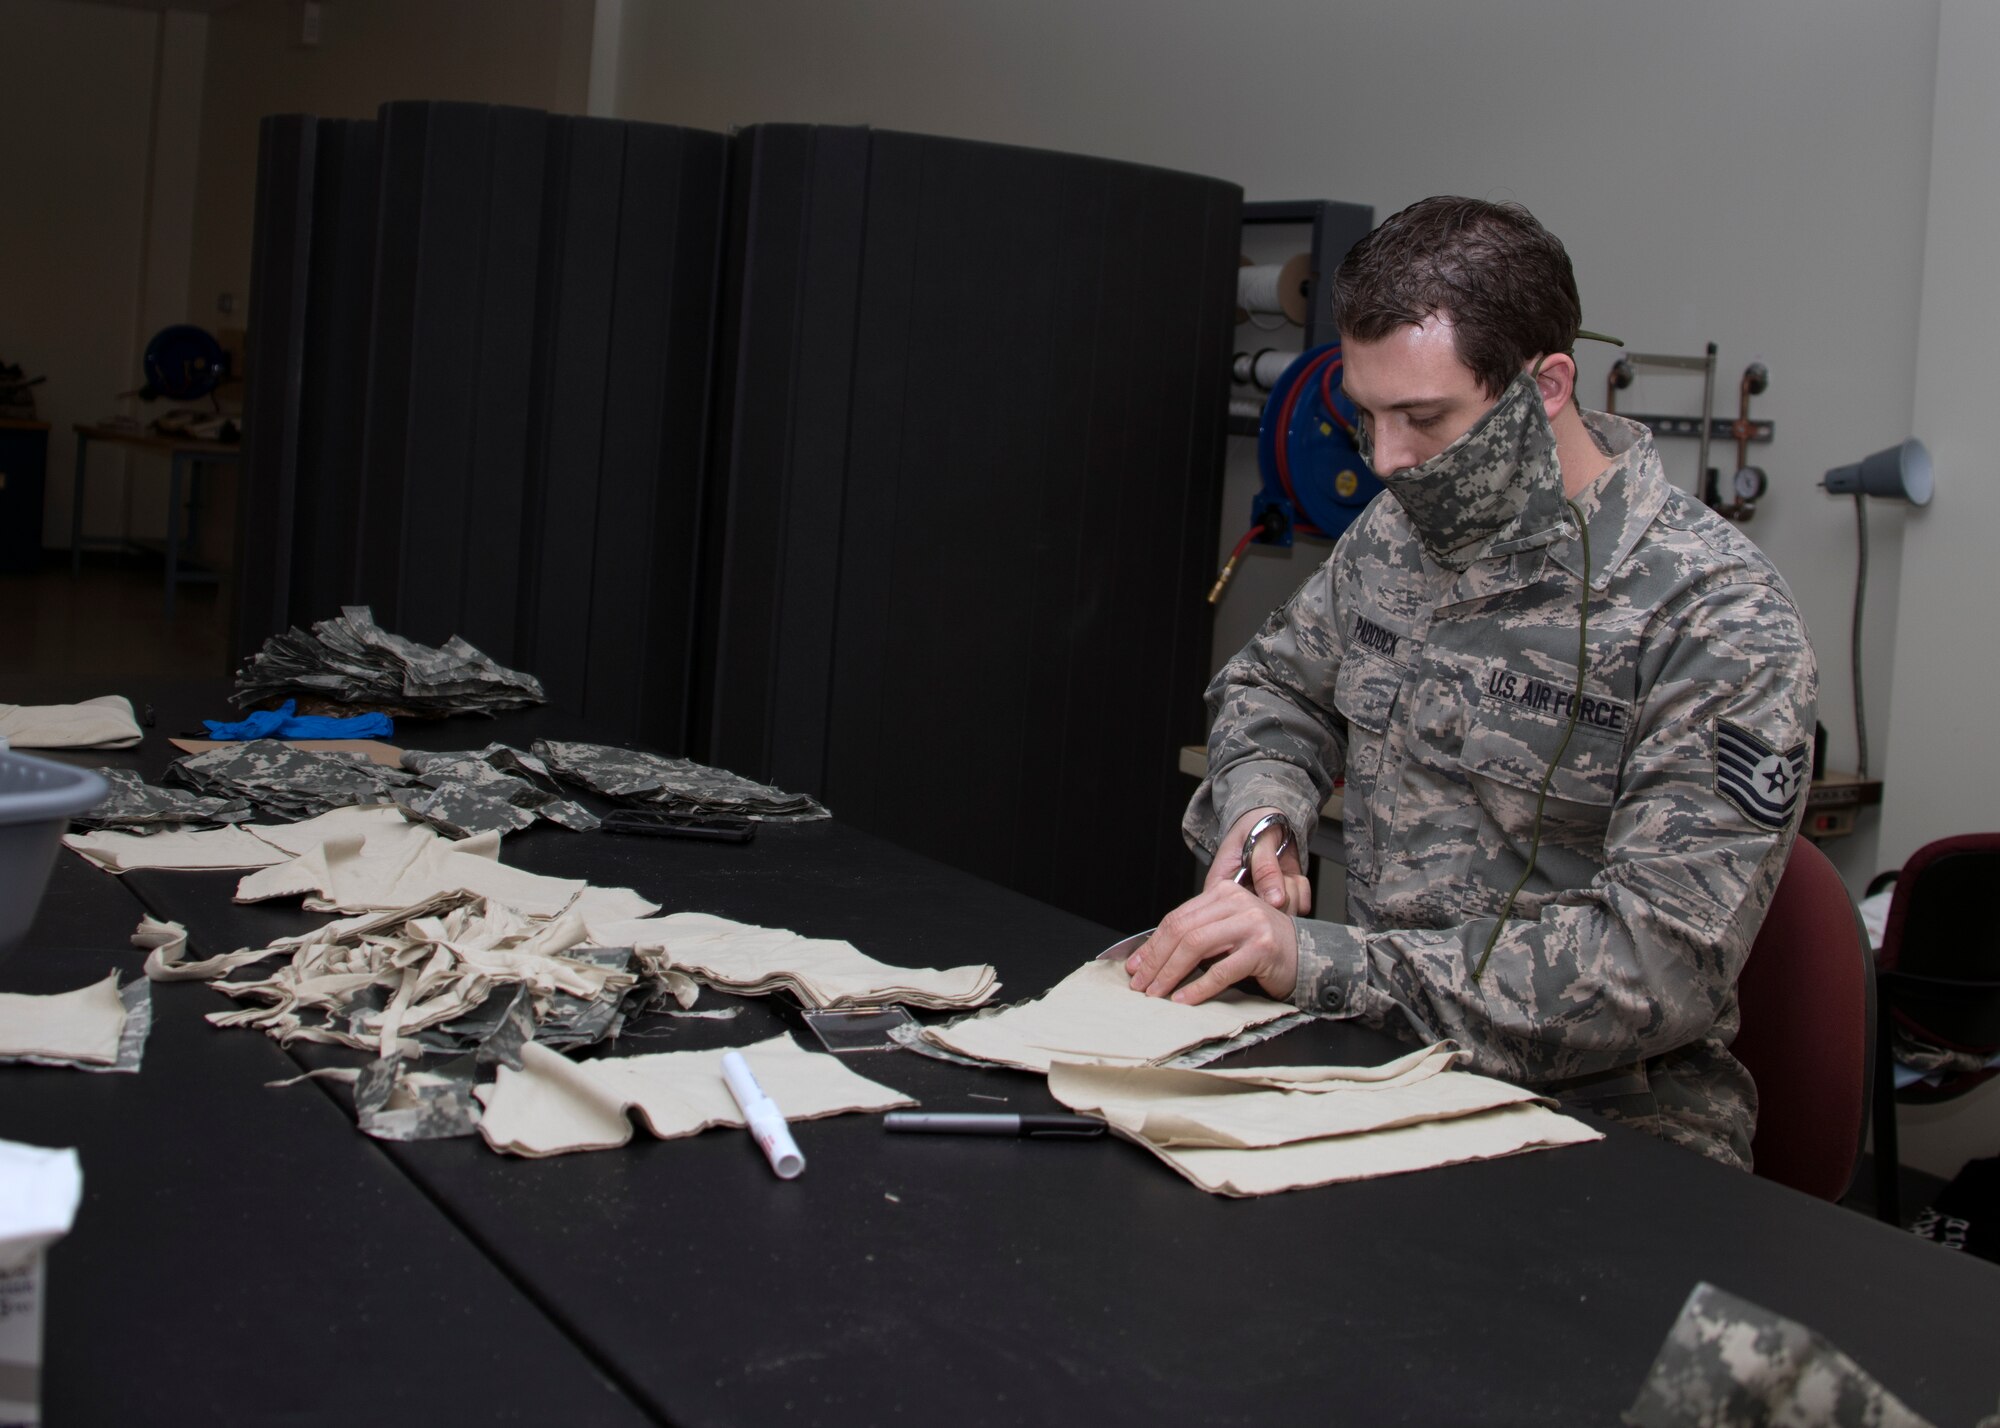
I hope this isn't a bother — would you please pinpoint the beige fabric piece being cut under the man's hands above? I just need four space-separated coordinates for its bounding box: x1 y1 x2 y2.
920 956 1294 1072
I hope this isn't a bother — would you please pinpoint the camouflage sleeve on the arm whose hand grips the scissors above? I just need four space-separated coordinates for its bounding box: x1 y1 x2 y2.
1180 560 1346 858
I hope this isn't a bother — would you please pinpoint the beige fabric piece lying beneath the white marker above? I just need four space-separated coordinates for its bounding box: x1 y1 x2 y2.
474 1036 916 1156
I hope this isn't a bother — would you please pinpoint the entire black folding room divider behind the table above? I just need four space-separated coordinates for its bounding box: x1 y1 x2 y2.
236 114 1242 926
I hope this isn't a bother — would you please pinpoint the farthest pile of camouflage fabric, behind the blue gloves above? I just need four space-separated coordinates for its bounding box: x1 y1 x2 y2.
230 604 544 718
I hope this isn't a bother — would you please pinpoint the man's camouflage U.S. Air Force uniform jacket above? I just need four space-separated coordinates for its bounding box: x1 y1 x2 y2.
1182 384 1818 1164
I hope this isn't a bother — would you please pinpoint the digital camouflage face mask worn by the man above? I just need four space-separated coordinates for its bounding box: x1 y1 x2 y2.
1360 372 1562 570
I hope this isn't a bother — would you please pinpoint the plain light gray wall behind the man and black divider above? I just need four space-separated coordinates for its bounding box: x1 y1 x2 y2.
618 0 1938 908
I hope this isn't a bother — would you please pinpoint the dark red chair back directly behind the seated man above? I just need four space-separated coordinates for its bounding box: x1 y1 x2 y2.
1730 838 1876 1200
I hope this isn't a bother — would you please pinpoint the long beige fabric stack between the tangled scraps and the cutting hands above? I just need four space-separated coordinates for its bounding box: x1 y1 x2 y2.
590 912 1000 1008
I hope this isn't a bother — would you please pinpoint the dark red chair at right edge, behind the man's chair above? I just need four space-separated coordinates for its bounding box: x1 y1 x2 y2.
1868 832 2000 1224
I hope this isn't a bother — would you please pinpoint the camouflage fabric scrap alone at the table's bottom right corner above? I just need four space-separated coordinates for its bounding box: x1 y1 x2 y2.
1624 1284 1936 1428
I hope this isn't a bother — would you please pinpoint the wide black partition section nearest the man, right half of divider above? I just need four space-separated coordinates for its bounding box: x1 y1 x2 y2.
698 126 1242 928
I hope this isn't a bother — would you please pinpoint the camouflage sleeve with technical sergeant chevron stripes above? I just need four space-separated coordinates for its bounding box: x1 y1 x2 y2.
1294 584 1818 1084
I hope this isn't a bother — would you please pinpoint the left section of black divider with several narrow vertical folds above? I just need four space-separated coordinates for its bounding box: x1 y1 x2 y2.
234 102 728 752
